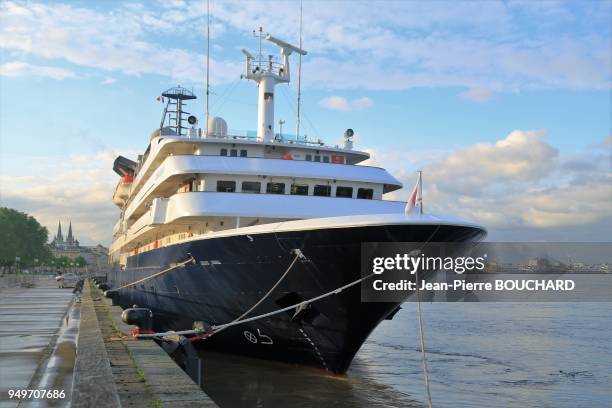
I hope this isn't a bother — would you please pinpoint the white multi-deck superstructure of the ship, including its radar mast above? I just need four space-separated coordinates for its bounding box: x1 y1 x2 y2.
110 35 430 264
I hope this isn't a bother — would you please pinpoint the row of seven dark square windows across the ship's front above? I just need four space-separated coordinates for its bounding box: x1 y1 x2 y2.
217 180 374 200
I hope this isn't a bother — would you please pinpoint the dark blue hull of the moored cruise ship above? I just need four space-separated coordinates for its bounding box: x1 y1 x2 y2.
109 225 484 373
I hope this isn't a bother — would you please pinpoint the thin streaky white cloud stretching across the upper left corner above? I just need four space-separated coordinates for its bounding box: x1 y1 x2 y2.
0 2 242 83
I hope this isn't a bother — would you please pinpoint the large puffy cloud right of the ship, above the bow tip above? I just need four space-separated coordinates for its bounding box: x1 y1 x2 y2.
373 130 612 234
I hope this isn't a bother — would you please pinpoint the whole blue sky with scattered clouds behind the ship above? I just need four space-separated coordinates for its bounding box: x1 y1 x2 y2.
0 0 612 244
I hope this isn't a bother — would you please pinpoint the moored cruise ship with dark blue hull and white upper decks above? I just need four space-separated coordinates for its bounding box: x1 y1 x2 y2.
108 35 486 373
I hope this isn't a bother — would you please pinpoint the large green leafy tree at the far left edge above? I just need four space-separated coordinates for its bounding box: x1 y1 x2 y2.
0 207 51 266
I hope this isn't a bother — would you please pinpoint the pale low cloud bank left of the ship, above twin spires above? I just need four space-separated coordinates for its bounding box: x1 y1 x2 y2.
0 151 126 245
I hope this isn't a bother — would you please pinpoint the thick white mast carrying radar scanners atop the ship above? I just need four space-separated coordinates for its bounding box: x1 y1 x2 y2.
241 27 306 141
